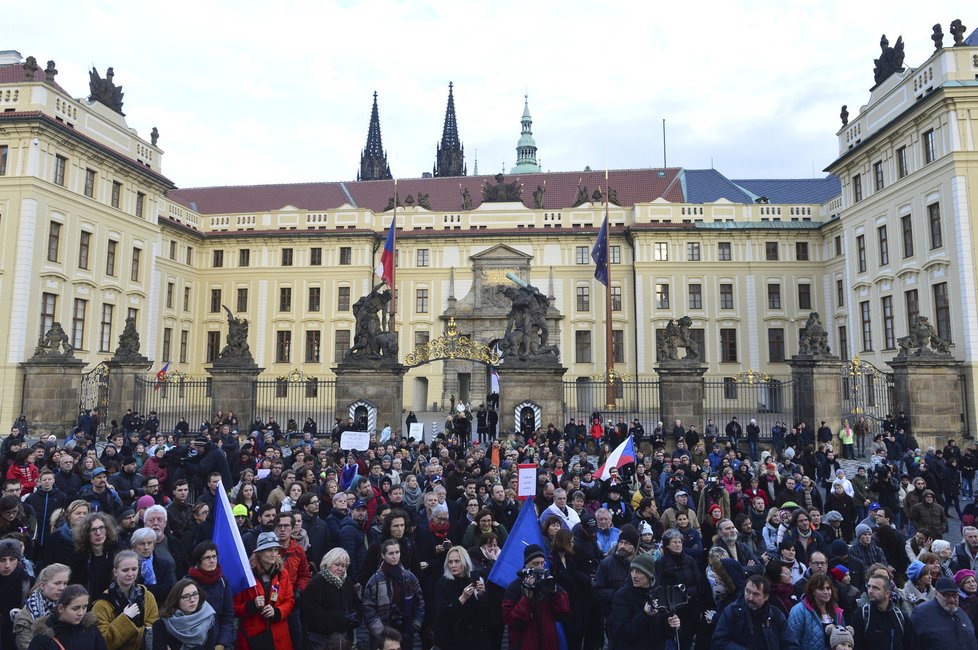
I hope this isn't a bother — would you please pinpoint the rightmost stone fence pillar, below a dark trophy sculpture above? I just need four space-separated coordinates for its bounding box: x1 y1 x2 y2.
888 354 964 449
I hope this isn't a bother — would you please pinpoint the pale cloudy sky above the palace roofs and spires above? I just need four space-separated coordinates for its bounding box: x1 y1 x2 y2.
9 0 978 187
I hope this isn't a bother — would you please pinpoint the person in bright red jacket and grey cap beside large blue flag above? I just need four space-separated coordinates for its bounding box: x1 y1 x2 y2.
234 533 294 650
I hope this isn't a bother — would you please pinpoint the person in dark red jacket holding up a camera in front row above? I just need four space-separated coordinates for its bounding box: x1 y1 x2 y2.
503 544 570 650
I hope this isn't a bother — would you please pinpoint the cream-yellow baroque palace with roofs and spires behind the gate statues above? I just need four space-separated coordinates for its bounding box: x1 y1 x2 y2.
0 30 978 429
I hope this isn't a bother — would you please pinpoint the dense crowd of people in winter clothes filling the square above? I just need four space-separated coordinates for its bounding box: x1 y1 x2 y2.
0 404 978 650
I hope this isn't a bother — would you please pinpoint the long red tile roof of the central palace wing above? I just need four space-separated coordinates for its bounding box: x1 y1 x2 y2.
168 167 685 214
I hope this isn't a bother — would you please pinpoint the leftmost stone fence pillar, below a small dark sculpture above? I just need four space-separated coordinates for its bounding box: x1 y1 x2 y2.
20 355 85 437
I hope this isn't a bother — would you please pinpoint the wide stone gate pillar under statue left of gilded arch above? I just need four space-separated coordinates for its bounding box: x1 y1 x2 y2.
334 361 408 436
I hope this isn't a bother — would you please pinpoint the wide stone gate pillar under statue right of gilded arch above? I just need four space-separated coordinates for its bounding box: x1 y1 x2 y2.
496 360 567 438
